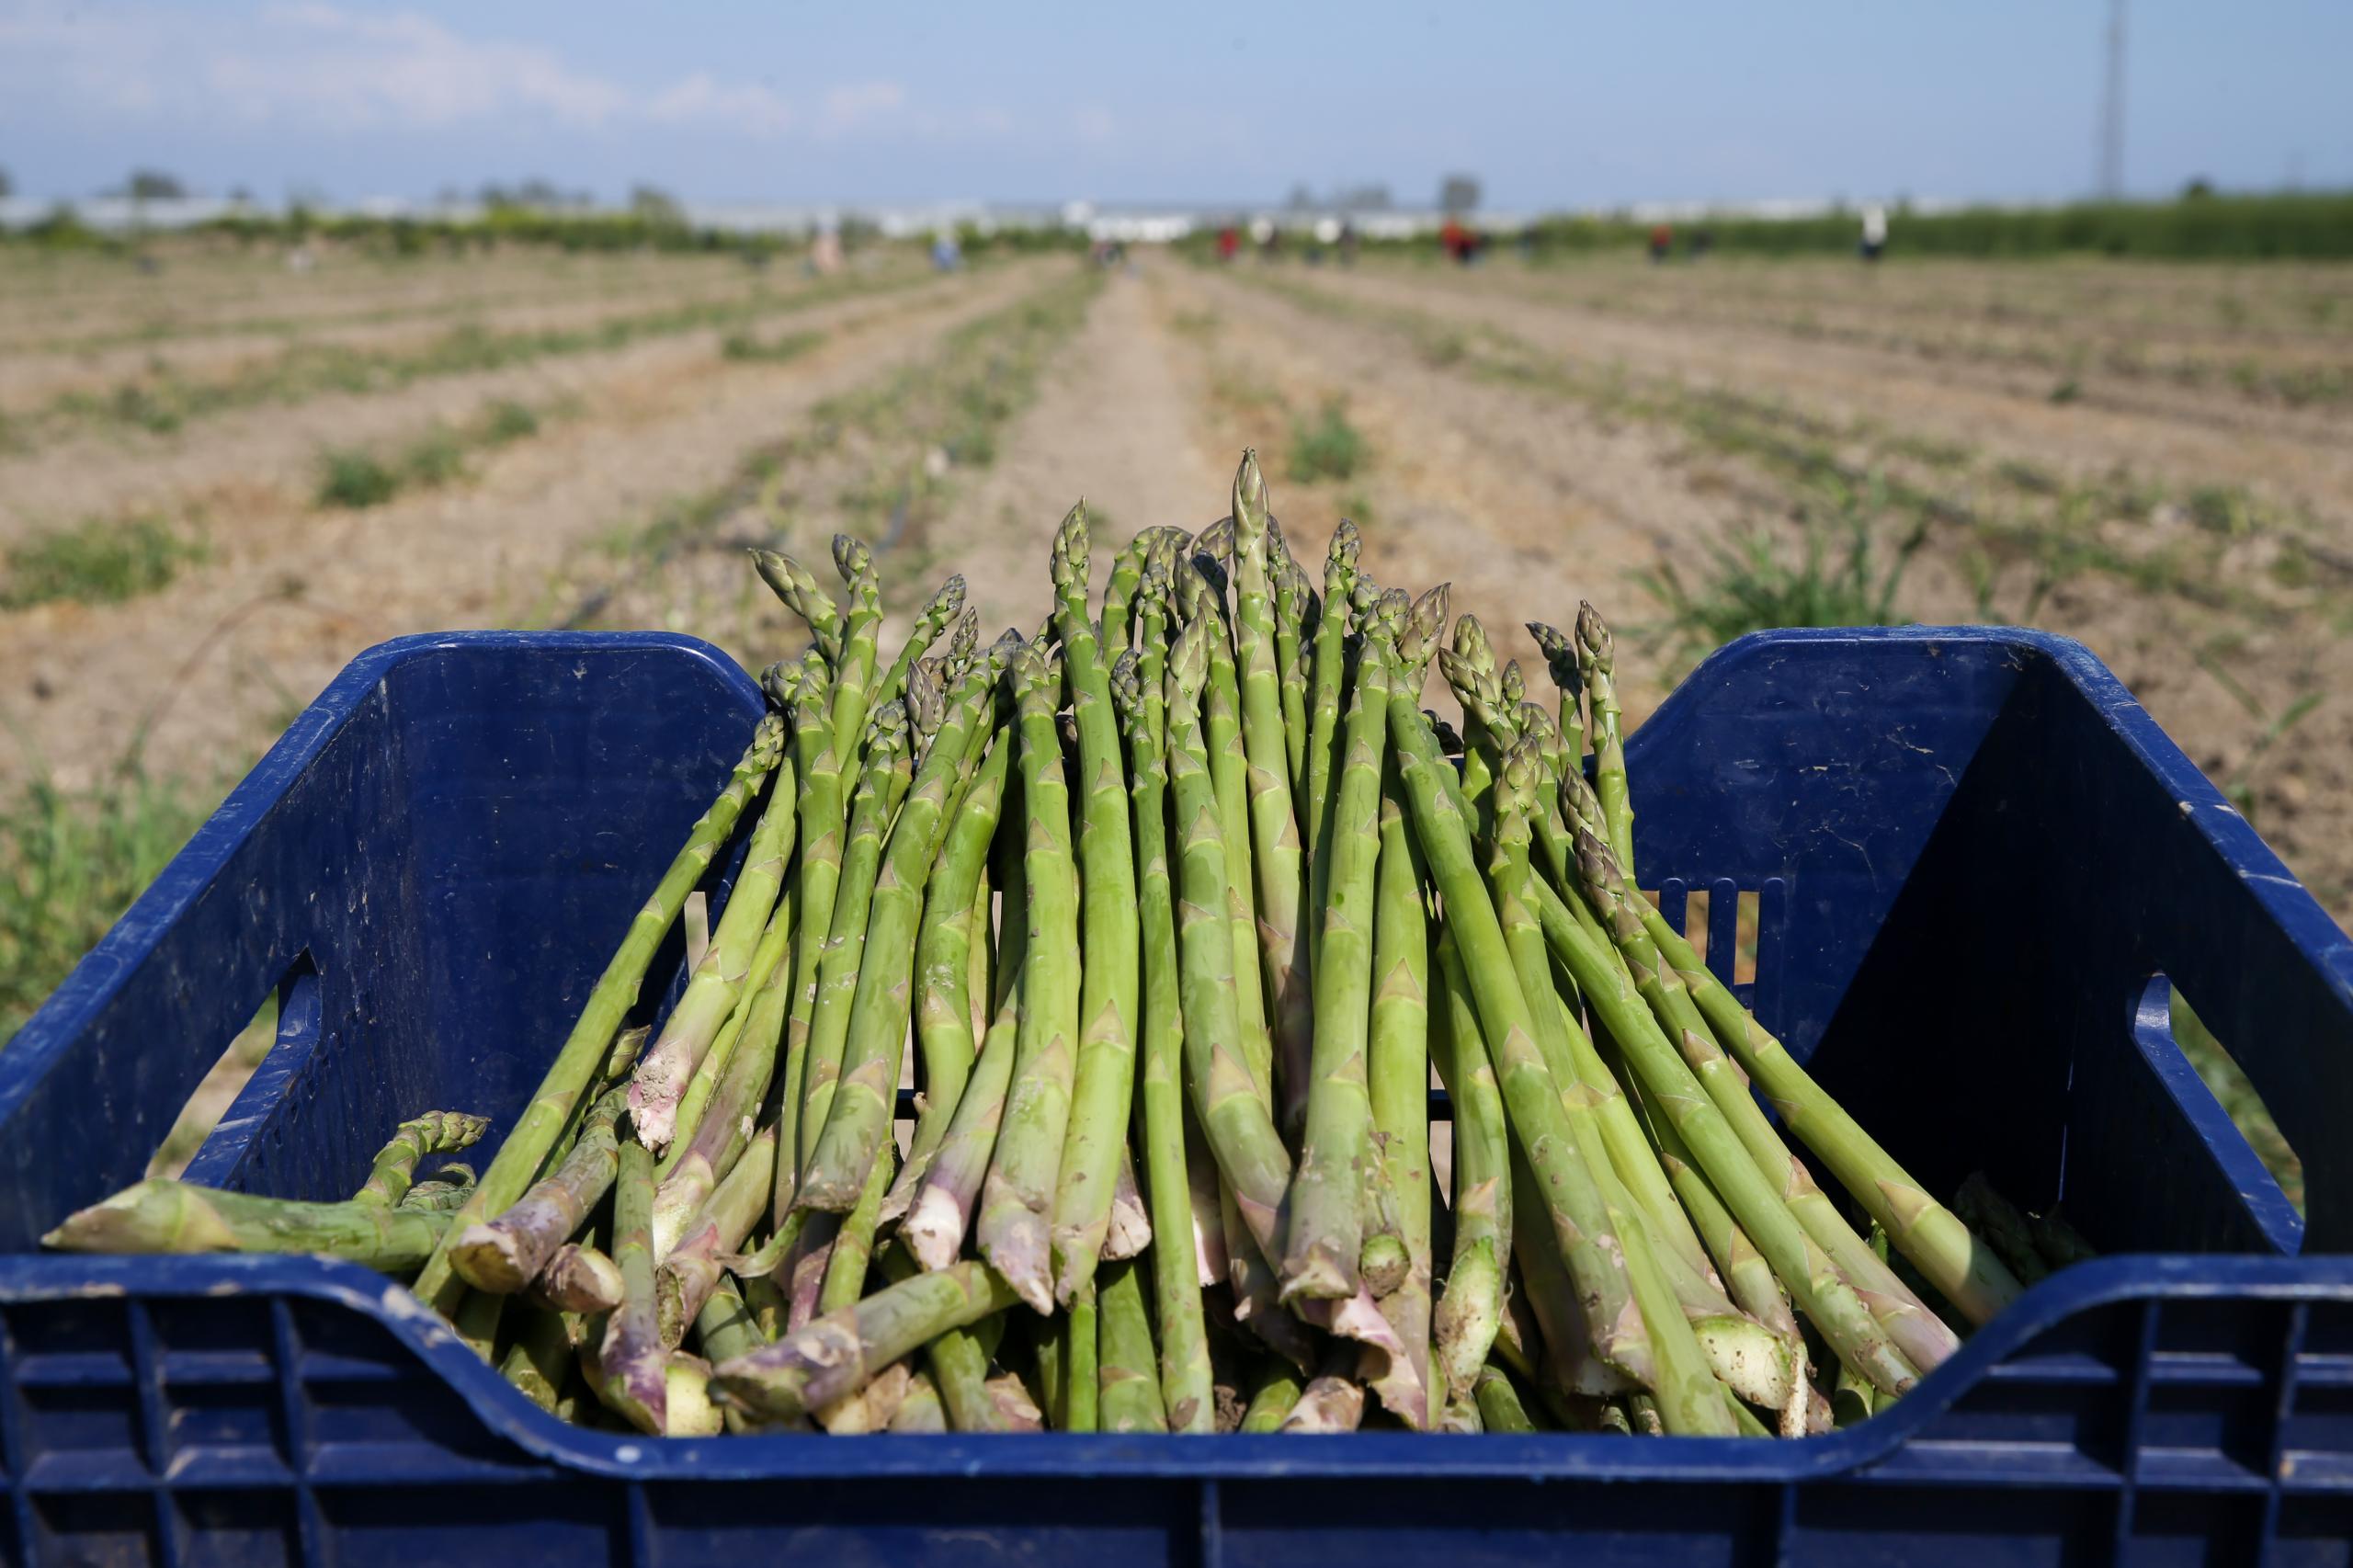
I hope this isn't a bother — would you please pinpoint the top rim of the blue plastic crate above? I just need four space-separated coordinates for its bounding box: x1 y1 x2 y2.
0 626 2353 1483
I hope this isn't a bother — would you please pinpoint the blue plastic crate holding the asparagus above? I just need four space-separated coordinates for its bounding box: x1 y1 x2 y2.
0 629 2353 1568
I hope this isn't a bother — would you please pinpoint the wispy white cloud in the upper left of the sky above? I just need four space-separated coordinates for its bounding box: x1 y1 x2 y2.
0 0 906 139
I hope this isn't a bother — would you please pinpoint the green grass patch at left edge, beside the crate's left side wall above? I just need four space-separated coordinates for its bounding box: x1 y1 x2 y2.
0 770 210 1040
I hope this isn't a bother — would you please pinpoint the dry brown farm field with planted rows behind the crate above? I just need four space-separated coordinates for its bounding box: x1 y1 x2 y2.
0 235 2353 1034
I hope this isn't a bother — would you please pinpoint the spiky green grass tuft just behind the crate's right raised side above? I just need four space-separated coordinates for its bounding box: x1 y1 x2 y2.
1635 475 1927 668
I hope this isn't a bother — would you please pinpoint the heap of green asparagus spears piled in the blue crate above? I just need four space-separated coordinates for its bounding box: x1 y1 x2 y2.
50 454 2083 1437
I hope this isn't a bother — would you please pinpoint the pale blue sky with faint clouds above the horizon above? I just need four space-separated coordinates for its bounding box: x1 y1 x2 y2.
0 0 2353 207
